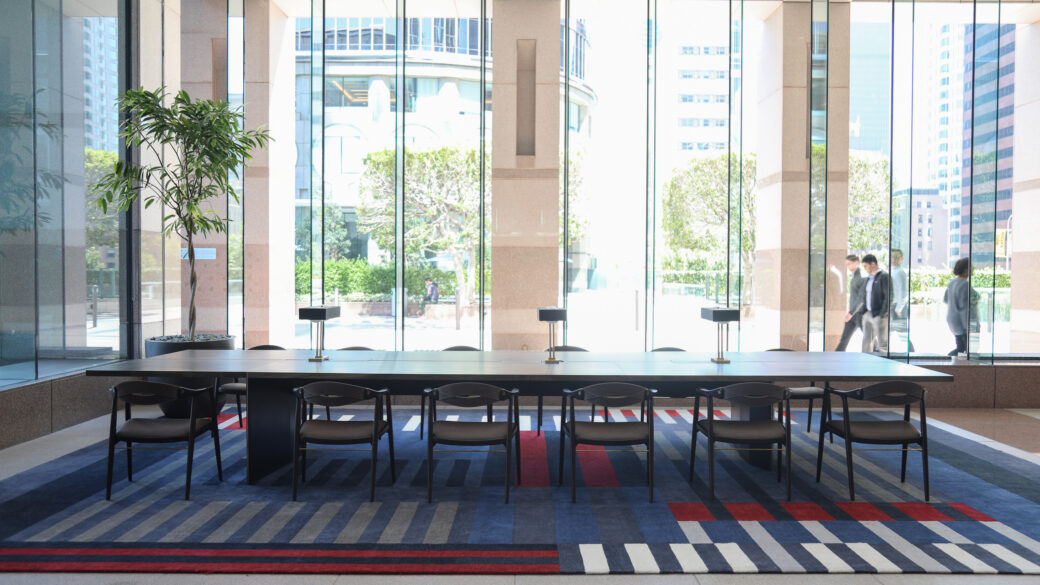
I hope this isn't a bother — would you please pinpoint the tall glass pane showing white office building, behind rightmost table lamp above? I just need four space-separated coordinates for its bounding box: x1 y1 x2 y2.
652 0 755 351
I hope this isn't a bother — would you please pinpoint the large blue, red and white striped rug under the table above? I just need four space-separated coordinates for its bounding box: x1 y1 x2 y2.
0 408 1040 574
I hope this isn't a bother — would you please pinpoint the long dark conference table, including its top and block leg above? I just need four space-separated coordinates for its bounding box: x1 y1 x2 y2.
86 350 953 483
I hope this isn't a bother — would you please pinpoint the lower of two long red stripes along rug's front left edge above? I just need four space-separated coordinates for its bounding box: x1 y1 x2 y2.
0 561 560 575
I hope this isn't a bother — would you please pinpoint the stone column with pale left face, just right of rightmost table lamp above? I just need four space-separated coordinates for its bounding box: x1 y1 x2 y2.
740 2 815 350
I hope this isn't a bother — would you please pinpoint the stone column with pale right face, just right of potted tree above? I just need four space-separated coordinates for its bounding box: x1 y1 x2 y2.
242 0 296 348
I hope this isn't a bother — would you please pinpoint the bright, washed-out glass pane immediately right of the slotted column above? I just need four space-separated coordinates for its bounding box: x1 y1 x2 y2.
561 0 648 351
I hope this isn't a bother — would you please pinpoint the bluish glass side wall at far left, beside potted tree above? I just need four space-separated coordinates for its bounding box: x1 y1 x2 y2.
0 0 126 385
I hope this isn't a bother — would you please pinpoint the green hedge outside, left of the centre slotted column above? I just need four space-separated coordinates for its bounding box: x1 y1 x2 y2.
296 258 456 300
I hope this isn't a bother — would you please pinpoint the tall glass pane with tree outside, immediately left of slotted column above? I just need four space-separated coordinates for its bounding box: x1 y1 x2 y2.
399 0 492 350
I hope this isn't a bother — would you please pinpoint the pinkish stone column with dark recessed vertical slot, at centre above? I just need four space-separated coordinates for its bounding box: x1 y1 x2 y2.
491 0 561 351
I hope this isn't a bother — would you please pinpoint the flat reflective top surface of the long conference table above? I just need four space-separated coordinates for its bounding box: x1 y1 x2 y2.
86 350 953 383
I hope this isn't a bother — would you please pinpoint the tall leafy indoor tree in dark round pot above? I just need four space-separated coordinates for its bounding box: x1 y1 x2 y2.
95 87 270 414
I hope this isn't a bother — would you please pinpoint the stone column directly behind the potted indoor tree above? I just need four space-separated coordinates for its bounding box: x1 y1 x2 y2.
178 0 228 333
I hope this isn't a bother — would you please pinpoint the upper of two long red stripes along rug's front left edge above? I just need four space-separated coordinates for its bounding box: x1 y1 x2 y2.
0 546 560 559
